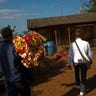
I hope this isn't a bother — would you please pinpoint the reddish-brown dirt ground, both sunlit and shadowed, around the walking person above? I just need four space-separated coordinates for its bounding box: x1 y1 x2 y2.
0 51 96 96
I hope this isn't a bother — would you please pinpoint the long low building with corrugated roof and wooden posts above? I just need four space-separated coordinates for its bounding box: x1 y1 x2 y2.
27 12 96 51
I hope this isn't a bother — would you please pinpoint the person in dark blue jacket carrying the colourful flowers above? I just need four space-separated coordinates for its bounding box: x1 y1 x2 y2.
0 26 32 96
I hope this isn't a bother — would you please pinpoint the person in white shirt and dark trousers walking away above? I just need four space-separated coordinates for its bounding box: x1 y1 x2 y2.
68 28 93 96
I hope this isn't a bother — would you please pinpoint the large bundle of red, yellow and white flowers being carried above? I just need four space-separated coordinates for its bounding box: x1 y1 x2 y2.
13 33 43 68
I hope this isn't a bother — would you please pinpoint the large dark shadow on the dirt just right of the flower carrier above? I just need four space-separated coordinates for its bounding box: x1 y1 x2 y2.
32 58 66 85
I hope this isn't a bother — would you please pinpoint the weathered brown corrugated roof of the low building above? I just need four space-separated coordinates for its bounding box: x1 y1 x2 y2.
27 12 96 29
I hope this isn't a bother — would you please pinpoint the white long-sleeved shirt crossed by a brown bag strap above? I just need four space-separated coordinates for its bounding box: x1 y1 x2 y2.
68 38 93 65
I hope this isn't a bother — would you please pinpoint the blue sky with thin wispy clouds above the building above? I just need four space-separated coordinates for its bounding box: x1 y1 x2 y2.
0 0 89 33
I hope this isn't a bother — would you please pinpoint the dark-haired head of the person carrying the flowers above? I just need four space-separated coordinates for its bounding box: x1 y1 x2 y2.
1 26 13 40
